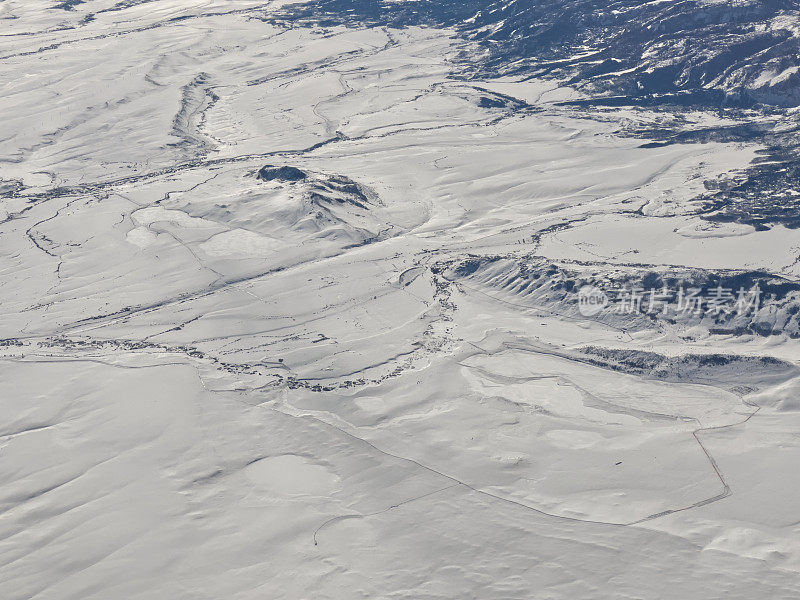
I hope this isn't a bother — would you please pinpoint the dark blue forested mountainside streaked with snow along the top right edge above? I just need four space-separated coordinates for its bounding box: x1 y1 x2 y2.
272 0 800 106
